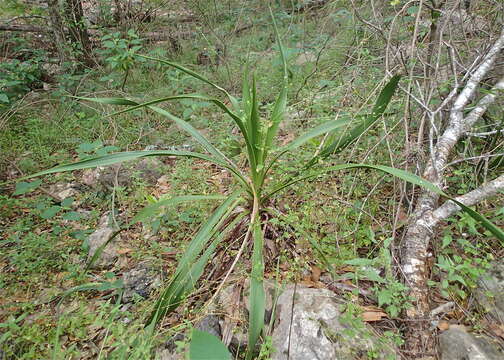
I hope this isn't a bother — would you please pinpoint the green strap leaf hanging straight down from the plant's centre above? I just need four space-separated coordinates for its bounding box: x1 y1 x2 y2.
246 215 265 360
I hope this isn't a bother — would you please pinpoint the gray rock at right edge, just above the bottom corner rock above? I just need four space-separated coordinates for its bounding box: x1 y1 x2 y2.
474 262 504 324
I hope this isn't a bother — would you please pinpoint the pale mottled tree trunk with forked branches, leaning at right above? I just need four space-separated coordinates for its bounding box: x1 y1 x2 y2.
402 28 504 355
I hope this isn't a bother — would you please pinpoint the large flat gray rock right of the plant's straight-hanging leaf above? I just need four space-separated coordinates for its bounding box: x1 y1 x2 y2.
272 286 395 360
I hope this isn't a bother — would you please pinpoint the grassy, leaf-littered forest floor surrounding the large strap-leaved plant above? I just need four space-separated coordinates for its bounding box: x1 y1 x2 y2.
0 2 504 359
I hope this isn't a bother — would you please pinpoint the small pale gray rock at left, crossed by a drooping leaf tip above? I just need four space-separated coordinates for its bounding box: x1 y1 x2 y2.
87 212 120 268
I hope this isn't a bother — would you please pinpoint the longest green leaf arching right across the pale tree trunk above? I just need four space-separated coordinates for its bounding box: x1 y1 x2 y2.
261 164 504 241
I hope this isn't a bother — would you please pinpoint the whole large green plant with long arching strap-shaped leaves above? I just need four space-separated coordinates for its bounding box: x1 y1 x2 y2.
23 9 504 359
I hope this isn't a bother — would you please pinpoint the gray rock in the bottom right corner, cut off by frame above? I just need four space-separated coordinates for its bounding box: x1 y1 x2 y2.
439 329 504 360
